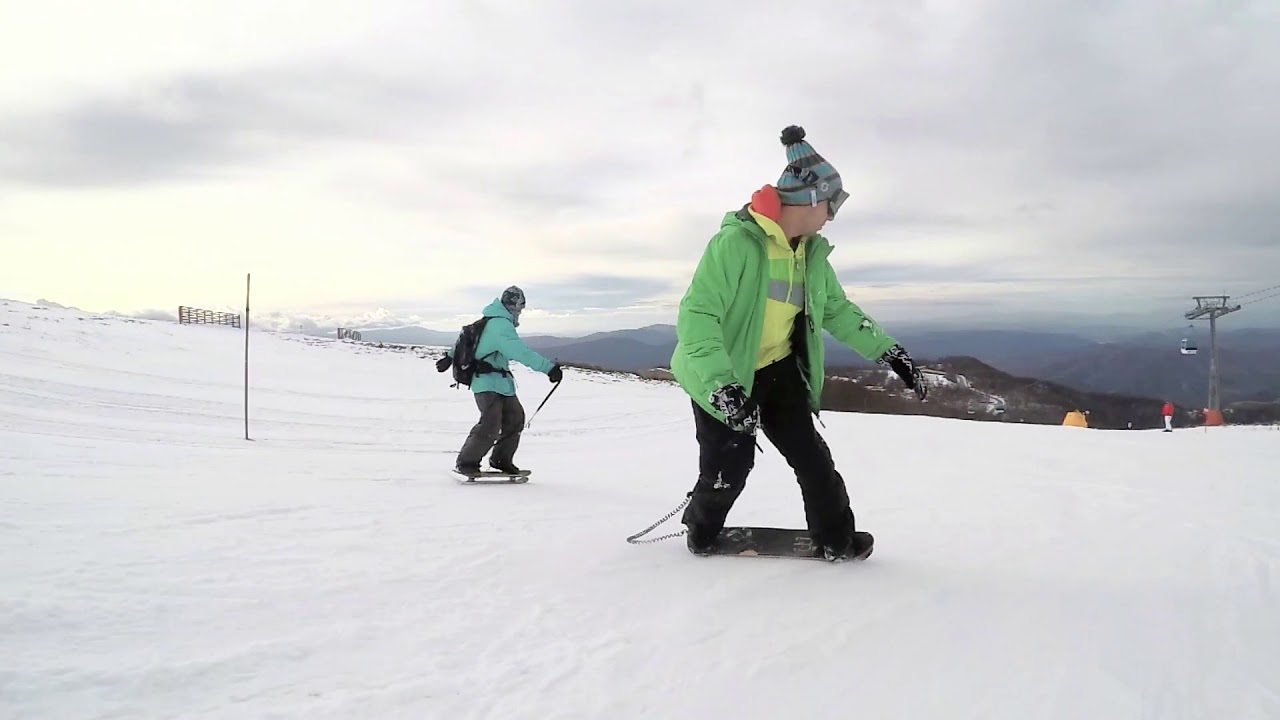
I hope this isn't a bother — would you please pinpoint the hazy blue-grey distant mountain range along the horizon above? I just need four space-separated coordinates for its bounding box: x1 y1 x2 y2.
340 324 1280 407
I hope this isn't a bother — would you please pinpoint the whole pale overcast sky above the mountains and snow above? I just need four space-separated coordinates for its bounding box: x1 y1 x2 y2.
0 0 1280 332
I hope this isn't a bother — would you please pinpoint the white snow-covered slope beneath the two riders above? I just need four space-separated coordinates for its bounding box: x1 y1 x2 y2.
0 302 1280 720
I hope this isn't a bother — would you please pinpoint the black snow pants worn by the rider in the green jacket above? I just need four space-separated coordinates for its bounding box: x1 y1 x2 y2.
682 355 854 547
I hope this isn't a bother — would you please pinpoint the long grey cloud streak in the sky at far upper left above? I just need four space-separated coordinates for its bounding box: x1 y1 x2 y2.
0 67 474 187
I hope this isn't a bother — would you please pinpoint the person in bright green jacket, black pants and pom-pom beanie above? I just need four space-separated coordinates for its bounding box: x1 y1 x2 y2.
671 126 927 561
